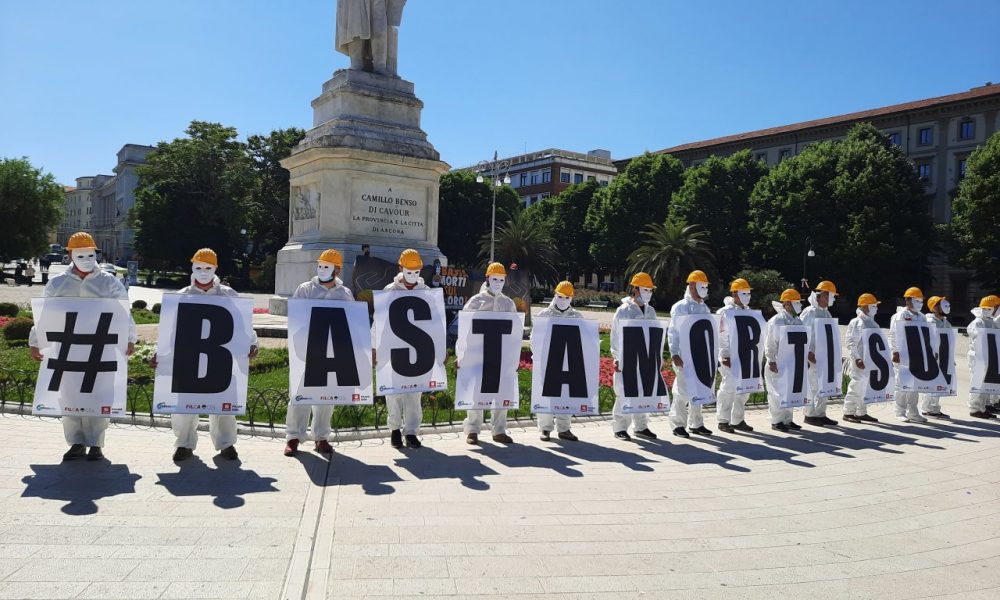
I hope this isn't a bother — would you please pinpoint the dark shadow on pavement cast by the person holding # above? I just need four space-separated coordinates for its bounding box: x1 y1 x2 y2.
21 460 142 515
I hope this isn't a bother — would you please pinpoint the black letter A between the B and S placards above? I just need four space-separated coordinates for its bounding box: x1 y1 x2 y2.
304 306 361 387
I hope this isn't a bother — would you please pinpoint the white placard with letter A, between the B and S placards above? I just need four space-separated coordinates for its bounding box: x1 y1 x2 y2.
288 299 374 405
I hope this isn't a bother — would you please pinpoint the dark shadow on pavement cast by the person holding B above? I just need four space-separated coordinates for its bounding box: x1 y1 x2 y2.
156 455 278 509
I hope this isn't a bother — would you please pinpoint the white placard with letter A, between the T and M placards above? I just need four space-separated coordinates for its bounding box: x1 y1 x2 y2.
531 317 601 415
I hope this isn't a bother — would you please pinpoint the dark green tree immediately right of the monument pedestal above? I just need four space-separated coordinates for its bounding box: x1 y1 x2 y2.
438 171 521 267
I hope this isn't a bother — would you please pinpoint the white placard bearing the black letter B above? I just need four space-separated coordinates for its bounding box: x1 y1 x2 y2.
153 294 253 415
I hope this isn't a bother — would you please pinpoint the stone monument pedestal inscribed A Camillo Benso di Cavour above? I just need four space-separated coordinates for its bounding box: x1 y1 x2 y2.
270 70 448 314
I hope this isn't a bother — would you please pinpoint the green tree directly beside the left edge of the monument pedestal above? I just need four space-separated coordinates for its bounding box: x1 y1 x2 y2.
244 127 305 262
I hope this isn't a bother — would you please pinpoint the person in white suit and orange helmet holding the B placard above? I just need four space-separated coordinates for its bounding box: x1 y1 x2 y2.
152 248 257 462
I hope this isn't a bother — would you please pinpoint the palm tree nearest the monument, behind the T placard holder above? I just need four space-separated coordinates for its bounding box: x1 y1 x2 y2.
479 210 556 282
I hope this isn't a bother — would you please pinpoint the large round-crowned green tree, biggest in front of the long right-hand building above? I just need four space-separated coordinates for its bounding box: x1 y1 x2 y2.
748 123 935 308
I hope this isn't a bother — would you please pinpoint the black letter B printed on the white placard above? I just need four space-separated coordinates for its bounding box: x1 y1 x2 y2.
170 302 236 394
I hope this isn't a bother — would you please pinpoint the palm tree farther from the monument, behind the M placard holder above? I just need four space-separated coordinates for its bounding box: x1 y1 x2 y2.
628 219 715 288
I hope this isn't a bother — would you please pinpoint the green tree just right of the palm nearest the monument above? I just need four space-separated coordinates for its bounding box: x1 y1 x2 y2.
526 181 601 279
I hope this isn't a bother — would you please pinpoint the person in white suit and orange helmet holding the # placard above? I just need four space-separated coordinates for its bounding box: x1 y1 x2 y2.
28 231 138 461
